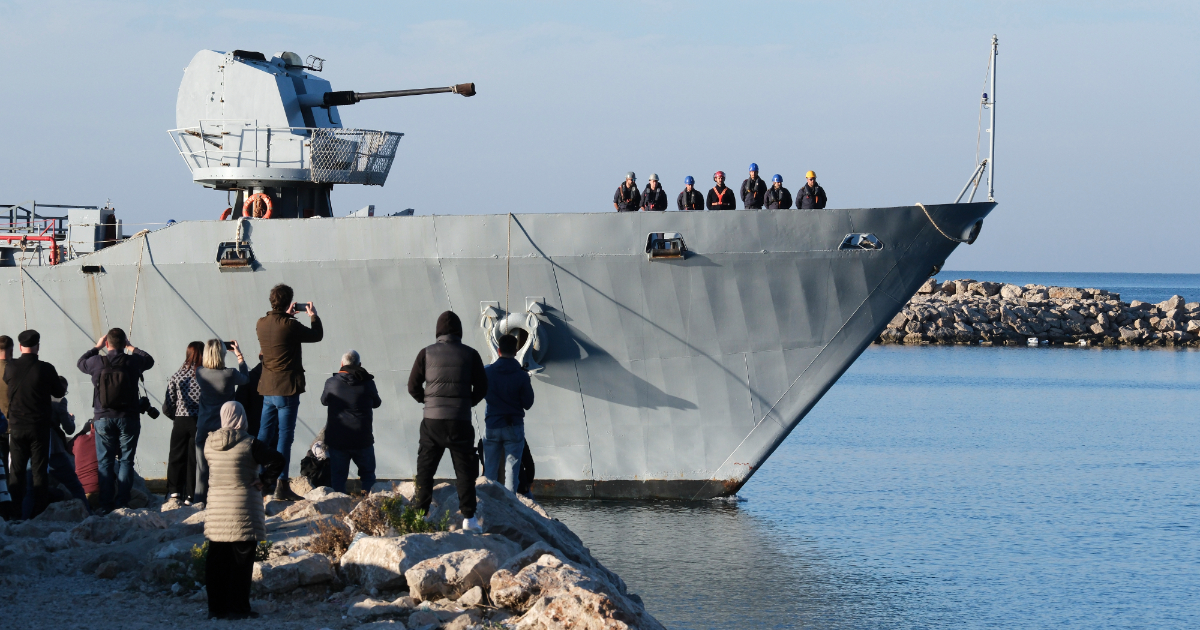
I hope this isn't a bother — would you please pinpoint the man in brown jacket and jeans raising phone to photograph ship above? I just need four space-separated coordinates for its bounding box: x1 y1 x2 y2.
257 284 325 500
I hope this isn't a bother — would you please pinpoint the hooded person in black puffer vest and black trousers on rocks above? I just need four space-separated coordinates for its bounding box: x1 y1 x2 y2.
408 312 487 532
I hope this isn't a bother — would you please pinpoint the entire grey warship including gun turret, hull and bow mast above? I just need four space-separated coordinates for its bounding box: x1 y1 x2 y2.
0 38 996 499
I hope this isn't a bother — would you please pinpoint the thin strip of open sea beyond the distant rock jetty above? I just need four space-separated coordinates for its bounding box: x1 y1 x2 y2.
937 271 1200 302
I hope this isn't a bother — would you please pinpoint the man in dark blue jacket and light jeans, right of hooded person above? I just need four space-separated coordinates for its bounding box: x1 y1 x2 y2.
484 335 533 492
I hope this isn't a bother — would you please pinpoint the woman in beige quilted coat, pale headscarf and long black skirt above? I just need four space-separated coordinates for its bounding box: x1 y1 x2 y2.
204 402 283 619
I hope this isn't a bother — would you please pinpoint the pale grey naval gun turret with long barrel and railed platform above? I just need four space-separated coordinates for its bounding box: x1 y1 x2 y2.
169 50 475 218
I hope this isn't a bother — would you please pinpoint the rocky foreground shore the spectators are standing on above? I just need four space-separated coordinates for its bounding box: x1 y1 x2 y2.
0 478 662 630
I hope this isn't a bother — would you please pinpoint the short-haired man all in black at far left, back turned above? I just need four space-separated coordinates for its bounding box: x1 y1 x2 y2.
4 330 67 517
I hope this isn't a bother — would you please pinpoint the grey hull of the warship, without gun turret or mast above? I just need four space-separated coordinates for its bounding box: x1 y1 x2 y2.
0 203 995 498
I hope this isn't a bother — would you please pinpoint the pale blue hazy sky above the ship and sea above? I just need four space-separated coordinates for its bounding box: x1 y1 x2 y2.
0 0 1200 272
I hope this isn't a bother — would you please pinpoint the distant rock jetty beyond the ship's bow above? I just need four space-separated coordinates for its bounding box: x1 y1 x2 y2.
876 278 1200 347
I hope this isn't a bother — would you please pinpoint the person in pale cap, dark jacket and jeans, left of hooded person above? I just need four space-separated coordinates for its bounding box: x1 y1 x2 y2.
320 350 383 492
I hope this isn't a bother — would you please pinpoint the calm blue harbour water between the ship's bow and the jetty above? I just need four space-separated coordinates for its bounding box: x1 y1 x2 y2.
547 343 1200 629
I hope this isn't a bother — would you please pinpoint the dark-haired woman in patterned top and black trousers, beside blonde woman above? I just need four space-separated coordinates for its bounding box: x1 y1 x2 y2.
162 341 204 505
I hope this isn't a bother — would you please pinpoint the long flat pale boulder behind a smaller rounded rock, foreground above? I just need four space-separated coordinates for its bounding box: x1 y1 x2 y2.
341 530 523 589
